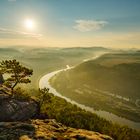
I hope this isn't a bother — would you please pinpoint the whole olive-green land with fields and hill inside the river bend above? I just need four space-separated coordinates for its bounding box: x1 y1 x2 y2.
51 53 140 122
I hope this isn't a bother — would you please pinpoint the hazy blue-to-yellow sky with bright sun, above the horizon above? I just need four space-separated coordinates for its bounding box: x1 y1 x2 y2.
0 0 140 48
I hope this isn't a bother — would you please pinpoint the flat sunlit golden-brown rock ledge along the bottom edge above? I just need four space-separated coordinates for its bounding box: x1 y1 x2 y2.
0 119 112 140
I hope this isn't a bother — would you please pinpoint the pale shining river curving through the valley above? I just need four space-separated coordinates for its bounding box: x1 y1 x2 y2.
39 57 140 130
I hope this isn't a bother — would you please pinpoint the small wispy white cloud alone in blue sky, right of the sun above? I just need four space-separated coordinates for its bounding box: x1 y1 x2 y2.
73 20 108 32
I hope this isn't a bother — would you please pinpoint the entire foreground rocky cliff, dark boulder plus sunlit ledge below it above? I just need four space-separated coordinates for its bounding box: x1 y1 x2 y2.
0 94 112 140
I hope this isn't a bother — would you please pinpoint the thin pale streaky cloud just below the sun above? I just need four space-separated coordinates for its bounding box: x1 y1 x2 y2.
0 28 43 39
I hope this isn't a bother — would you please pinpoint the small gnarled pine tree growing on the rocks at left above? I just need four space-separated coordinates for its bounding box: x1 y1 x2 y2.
0 59 33 95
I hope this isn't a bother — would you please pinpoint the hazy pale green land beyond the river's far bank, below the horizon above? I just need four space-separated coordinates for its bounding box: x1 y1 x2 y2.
0 46 111 88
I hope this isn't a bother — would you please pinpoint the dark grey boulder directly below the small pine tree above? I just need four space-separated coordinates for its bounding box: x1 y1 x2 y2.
0 94 38 121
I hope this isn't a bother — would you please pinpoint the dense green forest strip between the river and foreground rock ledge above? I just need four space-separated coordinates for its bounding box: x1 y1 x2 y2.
38 88 140 140
